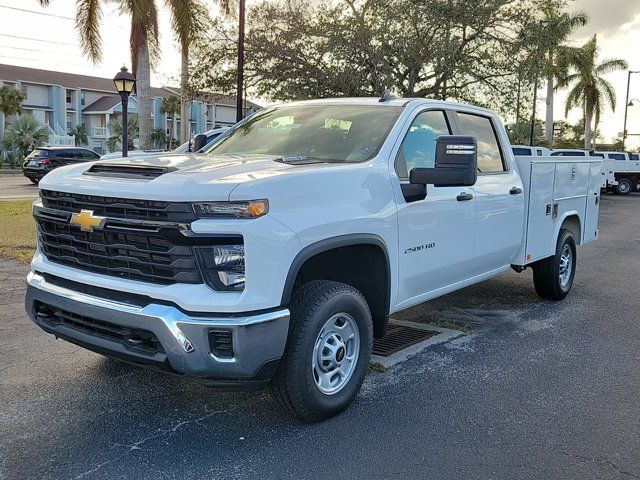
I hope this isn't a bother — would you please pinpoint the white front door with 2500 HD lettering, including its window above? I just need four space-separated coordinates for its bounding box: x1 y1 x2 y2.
396 110 475 307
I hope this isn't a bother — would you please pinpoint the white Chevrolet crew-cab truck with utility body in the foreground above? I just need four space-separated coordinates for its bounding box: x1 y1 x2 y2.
26 96 601 421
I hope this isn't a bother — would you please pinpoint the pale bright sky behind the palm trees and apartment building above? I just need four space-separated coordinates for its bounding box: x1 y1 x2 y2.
0 0 640 146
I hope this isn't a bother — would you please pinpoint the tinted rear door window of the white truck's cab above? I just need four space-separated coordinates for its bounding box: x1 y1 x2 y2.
458 112 505 173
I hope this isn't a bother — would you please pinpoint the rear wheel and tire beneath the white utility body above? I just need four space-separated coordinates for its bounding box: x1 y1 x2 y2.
533 228 577 300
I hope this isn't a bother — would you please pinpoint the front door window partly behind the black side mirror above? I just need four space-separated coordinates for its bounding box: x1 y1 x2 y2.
396 110 451 178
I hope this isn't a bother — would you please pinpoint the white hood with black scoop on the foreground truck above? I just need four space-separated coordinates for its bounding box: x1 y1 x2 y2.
40 154 312 201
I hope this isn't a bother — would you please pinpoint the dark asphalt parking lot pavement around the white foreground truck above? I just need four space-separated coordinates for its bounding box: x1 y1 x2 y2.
0 194 640 480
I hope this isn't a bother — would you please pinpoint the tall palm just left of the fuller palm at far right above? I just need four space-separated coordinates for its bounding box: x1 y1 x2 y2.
540 2 589 145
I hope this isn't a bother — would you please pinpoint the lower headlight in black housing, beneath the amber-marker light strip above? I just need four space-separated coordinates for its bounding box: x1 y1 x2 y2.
196 244 244 291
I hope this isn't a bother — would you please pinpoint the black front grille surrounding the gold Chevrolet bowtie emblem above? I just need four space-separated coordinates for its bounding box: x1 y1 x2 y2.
34 191 203 285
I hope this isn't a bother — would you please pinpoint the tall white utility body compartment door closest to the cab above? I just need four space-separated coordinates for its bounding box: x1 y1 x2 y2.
524 162 556 263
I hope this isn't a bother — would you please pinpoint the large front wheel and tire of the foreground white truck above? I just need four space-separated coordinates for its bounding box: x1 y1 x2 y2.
270 280 373 422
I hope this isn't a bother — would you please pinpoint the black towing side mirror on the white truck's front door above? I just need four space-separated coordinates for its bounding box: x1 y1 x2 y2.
409 135 478 187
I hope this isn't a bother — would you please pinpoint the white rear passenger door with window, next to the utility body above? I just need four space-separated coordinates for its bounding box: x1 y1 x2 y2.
457 111 524 276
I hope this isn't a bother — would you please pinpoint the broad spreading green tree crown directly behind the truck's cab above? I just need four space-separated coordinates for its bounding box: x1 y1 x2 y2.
191 0 552 116
